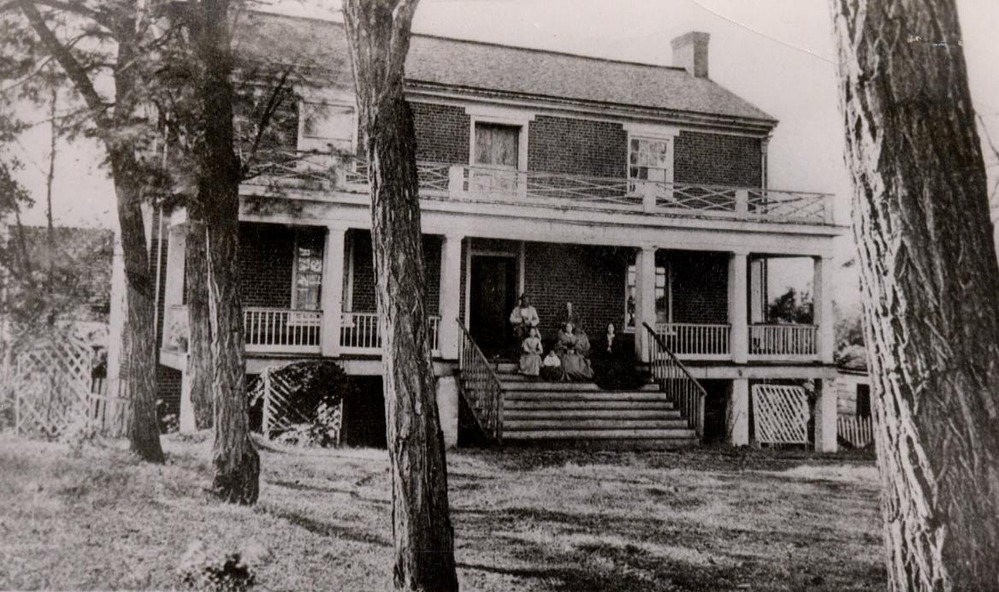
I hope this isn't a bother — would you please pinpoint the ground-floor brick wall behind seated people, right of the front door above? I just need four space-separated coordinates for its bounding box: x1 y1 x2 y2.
524 243 628 339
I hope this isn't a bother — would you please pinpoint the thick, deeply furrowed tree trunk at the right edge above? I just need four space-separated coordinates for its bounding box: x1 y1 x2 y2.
832 0 999 590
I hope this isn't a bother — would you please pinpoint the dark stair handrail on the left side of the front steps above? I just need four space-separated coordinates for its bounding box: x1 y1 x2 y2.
455 319 503 444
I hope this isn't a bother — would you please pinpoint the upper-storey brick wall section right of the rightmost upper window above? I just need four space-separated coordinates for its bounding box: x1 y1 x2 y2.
673 131 763 187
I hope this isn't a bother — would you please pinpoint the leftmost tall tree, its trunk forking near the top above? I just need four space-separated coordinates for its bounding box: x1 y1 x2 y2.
9 0 163 462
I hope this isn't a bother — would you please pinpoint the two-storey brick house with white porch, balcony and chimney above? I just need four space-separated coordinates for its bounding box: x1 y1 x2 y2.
154 13 843 449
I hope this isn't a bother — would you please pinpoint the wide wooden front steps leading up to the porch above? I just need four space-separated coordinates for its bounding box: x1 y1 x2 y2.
497 364 698 449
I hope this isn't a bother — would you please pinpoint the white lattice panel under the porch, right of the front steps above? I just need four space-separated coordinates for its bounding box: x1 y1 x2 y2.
753 384 808 444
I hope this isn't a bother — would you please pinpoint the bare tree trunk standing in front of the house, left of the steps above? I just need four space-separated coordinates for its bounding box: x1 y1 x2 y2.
344 0 458 590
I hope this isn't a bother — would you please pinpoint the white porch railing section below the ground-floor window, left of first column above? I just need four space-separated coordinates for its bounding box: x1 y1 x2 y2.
243 307 323 354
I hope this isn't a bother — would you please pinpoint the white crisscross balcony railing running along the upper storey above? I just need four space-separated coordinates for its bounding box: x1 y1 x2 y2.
238 151 833 224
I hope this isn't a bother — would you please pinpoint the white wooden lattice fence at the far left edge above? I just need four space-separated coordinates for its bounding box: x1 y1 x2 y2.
0 333 107 438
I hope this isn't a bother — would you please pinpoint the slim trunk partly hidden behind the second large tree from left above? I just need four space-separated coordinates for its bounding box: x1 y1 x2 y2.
184 208 215 430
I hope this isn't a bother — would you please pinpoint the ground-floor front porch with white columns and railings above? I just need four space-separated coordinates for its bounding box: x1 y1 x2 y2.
163 223 832 365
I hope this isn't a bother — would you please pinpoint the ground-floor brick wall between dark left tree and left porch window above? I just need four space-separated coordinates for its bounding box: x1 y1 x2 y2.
239 223 295 308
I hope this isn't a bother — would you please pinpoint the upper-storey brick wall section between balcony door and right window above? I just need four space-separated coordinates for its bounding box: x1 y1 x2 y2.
527 115 628 178
